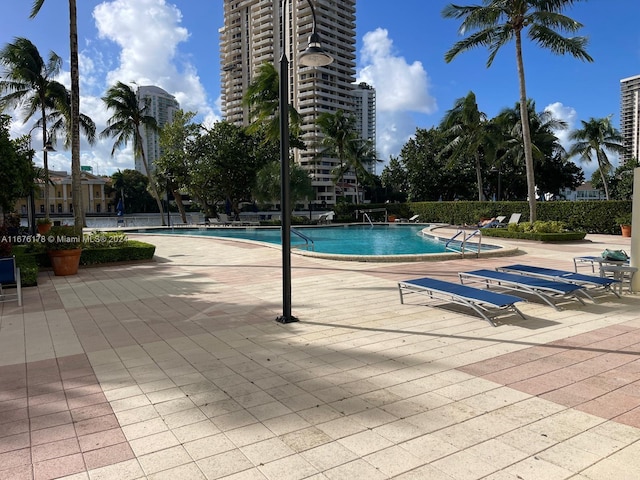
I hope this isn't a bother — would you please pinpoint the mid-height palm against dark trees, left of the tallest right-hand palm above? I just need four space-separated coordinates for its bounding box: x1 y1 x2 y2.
440 92 492 201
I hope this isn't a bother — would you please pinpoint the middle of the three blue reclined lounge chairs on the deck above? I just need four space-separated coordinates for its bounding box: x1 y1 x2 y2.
458 270 584 310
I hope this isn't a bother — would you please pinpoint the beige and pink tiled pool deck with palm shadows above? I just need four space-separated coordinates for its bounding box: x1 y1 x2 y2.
0 231 640 480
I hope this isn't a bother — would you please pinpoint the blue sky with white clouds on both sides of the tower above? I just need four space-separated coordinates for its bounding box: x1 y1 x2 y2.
0 0 640 178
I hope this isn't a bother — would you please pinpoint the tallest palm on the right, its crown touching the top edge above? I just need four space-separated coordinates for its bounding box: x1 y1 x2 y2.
442 0 593 222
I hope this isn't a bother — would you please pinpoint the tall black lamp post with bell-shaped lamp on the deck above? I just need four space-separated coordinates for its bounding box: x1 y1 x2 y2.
274 0 333 323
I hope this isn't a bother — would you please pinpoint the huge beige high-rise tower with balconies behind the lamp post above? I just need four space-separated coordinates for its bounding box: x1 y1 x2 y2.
220 0 356 205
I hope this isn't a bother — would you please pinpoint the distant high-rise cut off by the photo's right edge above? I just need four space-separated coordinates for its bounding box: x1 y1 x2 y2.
620 75 640 162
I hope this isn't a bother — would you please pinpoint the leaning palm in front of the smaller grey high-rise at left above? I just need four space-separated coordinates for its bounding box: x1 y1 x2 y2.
100 82 166 225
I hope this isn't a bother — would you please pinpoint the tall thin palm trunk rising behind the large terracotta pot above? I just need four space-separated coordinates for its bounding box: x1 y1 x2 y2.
30 0 84 229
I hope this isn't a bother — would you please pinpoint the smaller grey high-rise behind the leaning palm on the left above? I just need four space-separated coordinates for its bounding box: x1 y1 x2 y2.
135 85 180 175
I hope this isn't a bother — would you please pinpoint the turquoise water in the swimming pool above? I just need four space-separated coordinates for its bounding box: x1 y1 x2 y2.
139 225 480 255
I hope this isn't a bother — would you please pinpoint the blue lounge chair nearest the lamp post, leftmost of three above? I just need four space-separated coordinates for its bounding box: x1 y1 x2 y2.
398 278 526 327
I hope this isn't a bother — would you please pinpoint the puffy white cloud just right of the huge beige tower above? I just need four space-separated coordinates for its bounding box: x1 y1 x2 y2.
357 28 438 165
